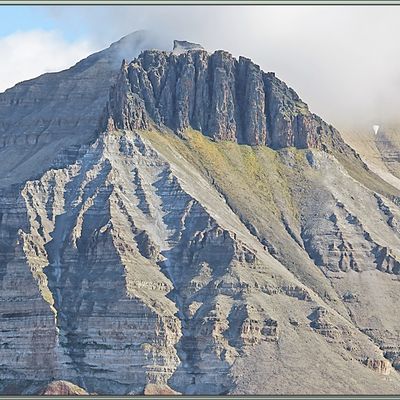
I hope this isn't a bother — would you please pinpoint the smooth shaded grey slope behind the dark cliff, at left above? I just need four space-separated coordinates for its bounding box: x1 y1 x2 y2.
0 31 158 187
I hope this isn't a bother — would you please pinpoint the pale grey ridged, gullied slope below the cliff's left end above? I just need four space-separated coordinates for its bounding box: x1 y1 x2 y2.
2 132 398 394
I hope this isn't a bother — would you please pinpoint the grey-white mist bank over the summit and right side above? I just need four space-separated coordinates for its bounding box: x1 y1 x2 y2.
49 6 400 129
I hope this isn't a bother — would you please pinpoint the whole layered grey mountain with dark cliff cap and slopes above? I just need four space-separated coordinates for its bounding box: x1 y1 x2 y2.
0 33 400 395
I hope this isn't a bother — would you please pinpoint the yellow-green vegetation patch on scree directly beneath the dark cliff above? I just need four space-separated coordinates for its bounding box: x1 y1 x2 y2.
143 130 302 225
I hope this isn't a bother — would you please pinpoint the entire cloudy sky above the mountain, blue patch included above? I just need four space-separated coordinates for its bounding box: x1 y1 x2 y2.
0 5 400 129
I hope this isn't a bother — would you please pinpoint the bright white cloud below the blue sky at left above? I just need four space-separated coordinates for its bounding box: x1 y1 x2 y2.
0 30 95 92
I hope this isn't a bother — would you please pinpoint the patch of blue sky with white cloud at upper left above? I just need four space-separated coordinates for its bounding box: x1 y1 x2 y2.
0 5 99 92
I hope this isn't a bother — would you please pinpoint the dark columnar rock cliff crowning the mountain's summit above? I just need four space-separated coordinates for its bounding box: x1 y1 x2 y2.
109 48 338 148
